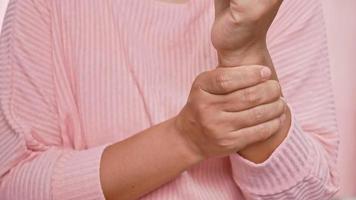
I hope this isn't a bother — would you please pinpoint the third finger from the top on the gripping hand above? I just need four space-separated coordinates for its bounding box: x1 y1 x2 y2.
226 99 286 130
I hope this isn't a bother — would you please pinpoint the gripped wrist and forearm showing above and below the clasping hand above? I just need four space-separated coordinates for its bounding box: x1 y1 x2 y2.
219 42 291 163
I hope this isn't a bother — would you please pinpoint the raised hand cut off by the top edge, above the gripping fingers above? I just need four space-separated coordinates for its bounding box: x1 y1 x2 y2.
211 0 283 66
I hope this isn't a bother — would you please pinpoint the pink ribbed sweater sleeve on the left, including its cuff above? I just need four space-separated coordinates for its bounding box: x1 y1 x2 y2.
0 0 105 200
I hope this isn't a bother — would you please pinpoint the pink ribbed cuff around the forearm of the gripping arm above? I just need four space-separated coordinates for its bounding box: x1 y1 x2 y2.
52 145 107 200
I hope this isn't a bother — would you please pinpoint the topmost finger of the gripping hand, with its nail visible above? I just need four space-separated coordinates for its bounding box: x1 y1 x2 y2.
193 65 271 95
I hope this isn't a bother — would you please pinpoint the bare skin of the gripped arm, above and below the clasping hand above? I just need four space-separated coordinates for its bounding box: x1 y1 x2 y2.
212 0 291 163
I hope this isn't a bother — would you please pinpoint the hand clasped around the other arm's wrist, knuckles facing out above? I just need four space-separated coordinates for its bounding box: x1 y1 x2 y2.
175 66 286 158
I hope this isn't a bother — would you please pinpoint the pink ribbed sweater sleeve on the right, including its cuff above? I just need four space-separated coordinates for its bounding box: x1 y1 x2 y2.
230 0 339 200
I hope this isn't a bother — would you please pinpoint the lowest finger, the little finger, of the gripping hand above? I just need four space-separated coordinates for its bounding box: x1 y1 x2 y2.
230 115 286 150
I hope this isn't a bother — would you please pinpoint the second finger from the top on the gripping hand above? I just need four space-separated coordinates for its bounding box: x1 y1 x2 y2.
220 80 282 112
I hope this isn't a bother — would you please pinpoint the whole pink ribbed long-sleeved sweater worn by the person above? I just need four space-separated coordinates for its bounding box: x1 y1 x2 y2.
0 0 339 200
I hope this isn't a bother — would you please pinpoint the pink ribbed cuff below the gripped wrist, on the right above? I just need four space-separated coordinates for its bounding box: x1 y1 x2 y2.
230 106 316 195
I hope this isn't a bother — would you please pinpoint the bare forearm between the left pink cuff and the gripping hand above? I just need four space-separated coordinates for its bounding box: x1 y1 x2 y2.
101 117 202 200
